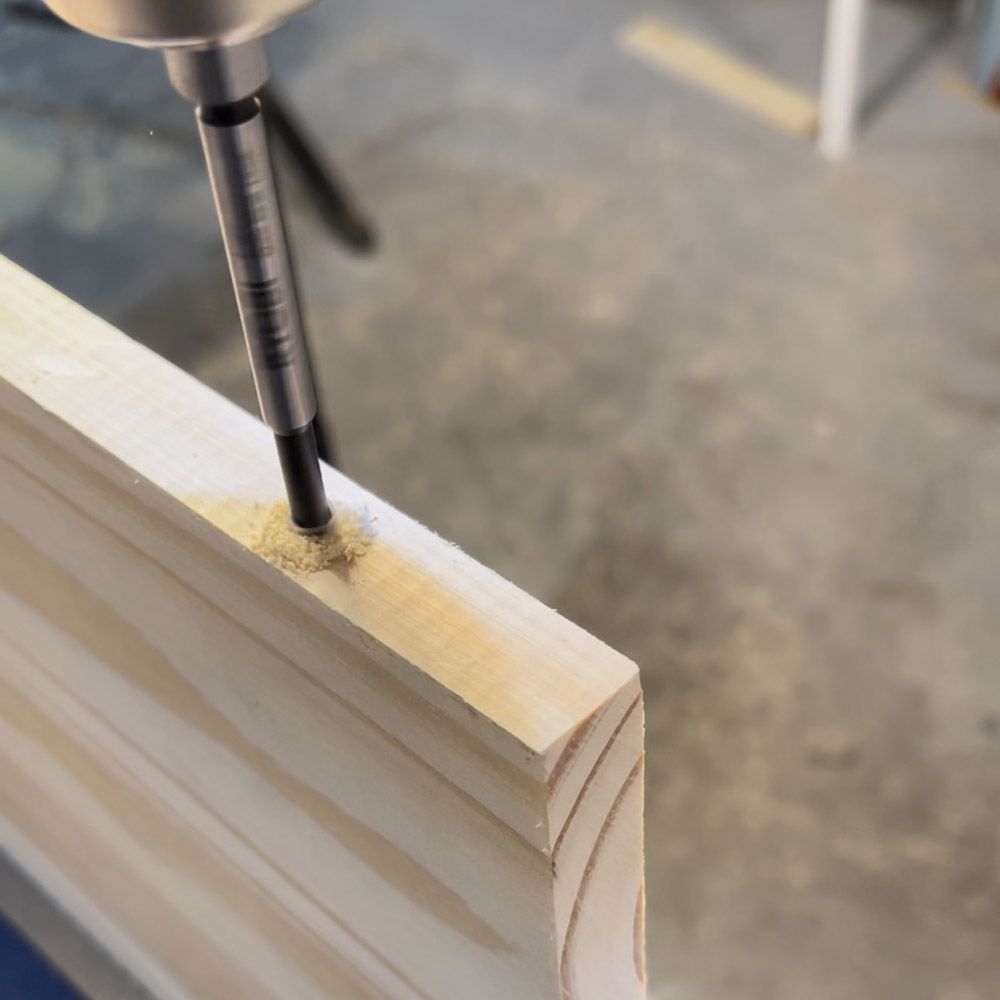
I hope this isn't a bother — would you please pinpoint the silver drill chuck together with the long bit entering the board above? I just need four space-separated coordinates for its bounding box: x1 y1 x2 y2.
34 0 330 531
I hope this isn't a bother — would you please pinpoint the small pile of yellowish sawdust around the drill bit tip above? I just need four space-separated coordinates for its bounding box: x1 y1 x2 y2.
250 502 372 573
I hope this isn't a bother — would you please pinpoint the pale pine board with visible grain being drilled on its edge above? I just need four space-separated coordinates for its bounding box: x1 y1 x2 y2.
0 259 645 1000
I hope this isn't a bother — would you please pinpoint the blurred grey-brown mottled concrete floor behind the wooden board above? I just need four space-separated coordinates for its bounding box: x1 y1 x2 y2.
0 0 1000 1000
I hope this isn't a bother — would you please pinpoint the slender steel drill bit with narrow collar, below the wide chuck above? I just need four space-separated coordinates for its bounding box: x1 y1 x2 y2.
166 40 331 532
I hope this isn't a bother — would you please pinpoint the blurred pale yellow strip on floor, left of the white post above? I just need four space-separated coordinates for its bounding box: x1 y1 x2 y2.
619 18 819 137
